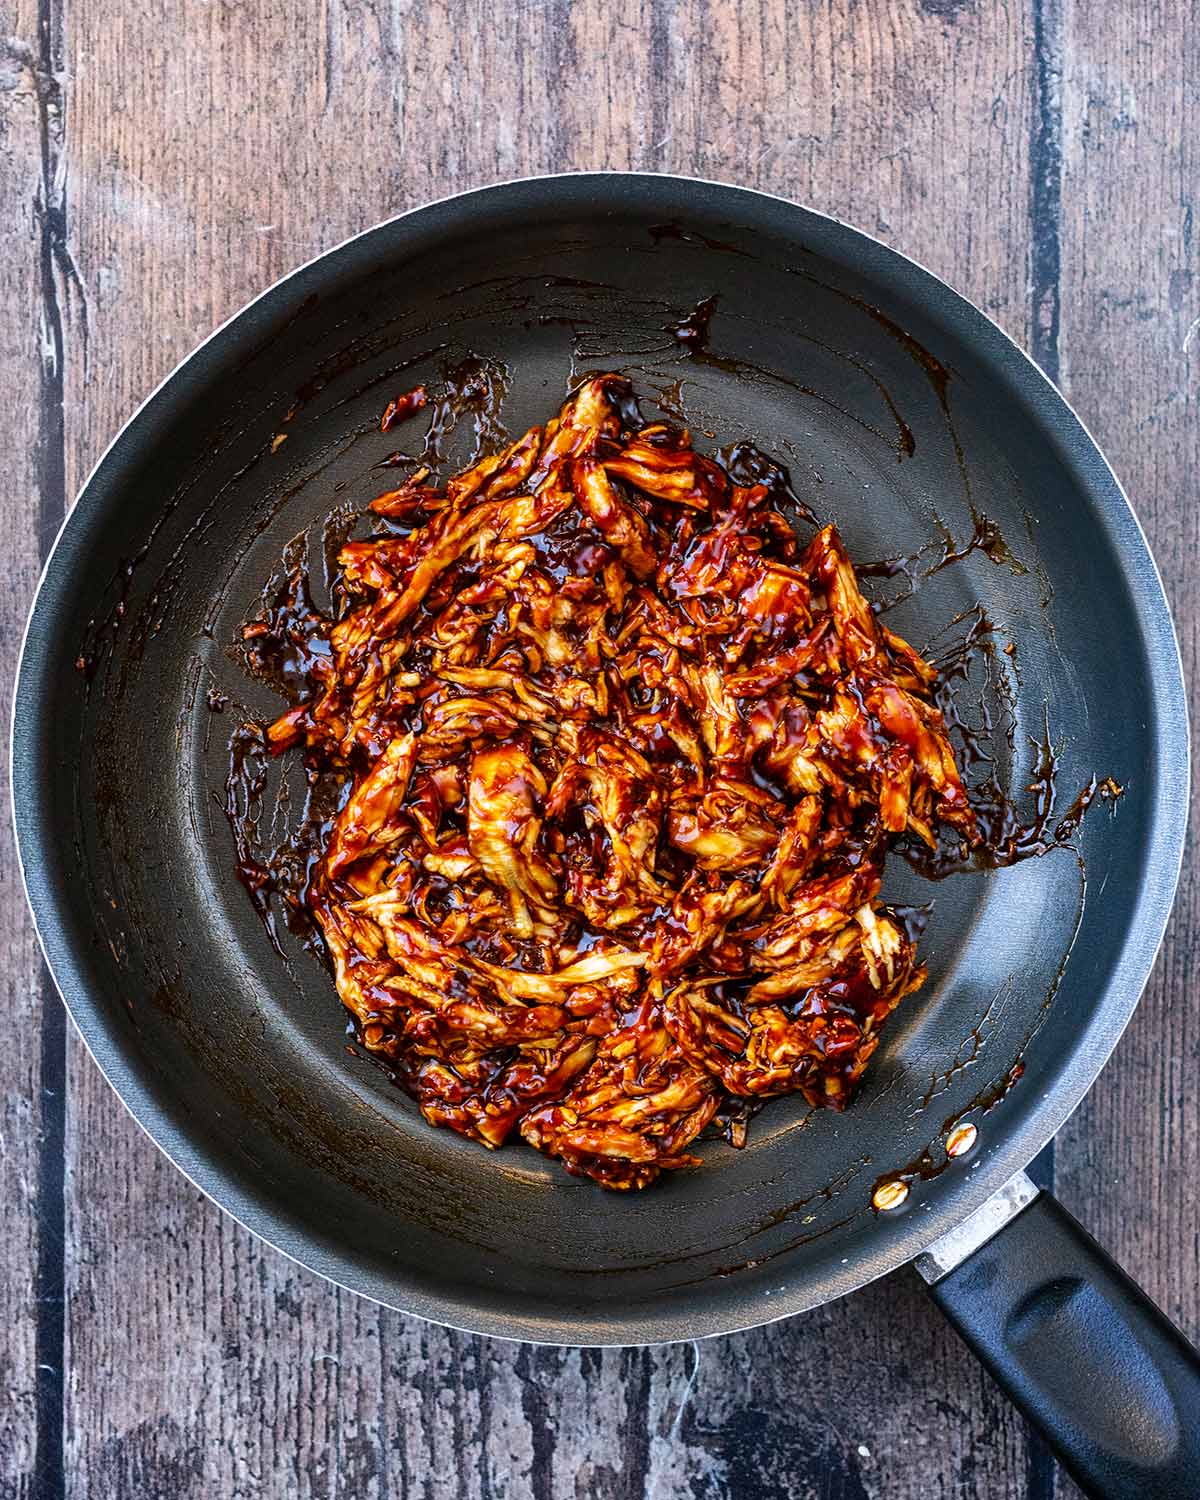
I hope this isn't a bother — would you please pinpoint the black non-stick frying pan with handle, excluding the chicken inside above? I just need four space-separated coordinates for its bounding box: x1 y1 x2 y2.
14 174 1200 1496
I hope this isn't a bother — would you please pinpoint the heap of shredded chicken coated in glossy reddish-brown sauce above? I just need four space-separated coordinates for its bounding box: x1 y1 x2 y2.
255 375 975 1188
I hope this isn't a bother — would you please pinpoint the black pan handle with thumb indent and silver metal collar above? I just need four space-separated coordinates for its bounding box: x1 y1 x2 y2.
917 1172 1200 1500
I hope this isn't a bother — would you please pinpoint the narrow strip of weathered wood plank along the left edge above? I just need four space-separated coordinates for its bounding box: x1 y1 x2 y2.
0 0 66 1497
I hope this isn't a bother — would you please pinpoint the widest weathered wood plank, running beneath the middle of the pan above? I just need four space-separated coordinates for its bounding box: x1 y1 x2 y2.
44 0 1200 1500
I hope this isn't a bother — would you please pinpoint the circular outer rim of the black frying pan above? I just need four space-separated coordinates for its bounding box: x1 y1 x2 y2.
11 171 1190 1347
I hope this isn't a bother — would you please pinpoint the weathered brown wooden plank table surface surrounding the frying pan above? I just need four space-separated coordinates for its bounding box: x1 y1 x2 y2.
0 0 1200 1500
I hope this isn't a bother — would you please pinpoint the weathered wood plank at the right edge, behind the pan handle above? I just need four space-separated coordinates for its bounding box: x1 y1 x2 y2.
1059 0 1200 1380
